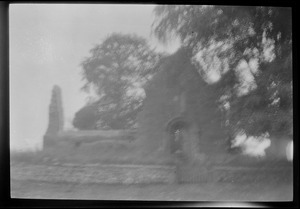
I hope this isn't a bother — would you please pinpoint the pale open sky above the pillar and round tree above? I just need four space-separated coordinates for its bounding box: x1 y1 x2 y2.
9 4 178 149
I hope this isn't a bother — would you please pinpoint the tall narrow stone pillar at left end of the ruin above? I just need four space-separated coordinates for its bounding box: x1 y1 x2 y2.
44 85 64 148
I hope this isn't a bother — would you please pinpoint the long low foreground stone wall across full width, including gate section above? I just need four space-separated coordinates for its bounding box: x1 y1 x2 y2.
11 164 293 184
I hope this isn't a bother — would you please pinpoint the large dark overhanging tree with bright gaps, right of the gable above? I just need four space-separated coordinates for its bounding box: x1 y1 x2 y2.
153 5 292 140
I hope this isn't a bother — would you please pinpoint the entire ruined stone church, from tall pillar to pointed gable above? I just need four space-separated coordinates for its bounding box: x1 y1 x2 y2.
44 49 224 165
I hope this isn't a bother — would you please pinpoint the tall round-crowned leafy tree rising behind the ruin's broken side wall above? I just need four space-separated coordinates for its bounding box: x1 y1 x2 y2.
77 33 162 129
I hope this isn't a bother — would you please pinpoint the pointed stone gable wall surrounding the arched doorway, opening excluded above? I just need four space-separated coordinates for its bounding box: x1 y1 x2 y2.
137 48 224 158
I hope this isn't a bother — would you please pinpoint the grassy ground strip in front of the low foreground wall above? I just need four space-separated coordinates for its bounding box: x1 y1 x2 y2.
11 180 293 202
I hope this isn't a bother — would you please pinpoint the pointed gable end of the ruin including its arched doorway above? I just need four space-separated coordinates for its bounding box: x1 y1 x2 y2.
137 48 225 172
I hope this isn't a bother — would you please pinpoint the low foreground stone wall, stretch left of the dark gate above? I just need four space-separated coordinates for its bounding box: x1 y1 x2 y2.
11 164 175 184
